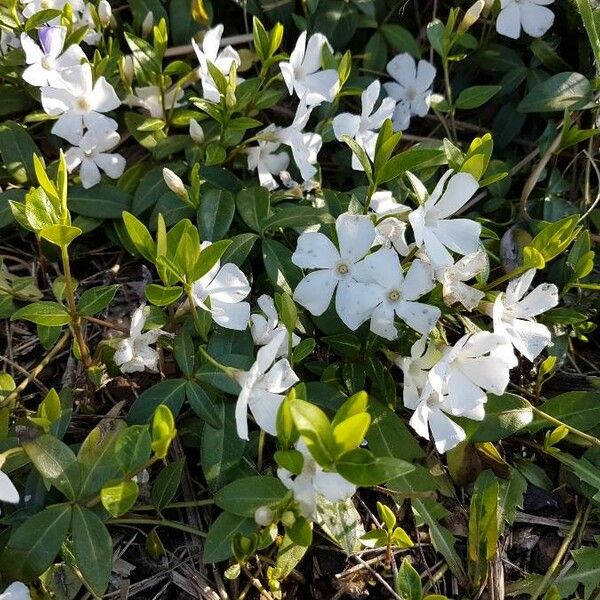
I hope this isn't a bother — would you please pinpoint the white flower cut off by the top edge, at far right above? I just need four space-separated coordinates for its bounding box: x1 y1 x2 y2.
496 0 554 40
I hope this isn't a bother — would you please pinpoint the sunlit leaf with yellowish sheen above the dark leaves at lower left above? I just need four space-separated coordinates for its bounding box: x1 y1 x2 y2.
22 434 81 500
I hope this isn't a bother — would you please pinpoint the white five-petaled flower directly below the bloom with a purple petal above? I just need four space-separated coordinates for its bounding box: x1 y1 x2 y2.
42 64 121 144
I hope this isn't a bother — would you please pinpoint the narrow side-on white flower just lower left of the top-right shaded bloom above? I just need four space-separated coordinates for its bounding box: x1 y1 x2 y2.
333 80 395 171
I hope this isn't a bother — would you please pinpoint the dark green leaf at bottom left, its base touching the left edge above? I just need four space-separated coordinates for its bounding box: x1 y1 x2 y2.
0 504 73 582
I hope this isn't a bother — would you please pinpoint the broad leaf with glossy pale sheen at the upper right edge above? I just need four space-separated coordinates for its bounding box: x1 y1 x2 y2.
517 72 592 113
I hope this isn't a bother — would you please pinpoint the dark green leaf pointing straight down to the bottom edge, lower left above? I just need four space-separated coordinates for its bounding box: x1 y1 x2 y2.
71 505 113 598
